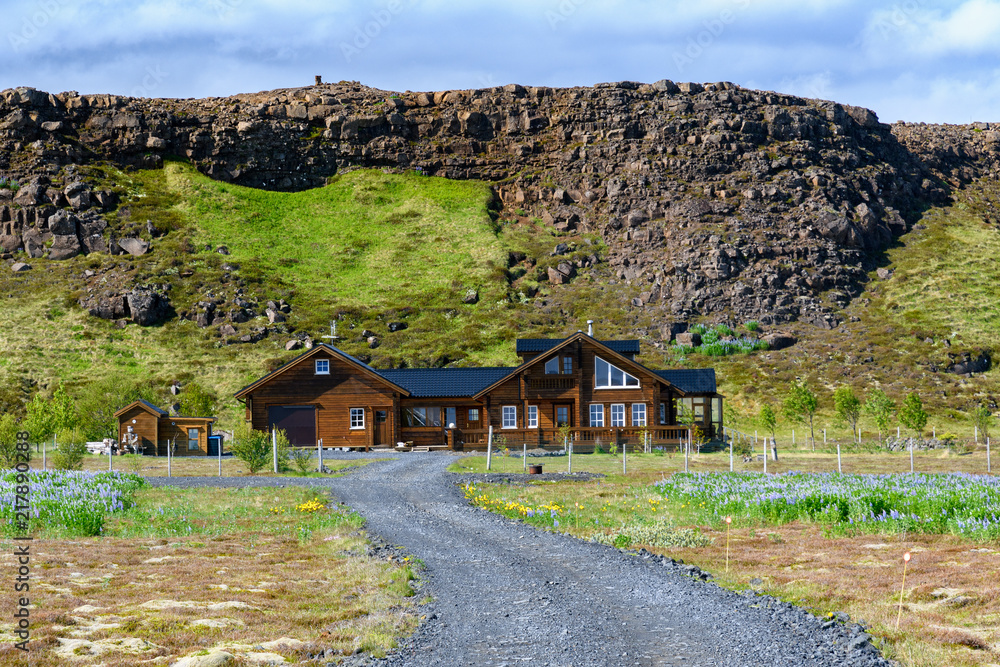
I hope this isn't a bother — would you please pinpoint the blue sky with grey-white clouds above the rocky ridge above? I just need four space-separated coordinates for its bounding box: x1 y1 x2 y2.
0 0 1000 123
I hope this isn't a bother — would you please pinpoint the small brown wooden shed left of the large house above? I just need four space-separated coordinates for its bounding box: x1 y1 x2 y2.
115 401 215 456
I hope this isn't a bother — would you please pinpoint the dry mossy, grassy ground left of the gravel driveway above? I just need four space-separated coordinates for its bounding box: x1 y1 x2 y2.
0 488 418 667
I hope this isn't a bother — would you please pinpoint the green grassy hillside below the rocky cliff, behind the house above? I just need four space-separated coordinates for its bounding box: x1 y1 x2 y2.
0 162 1000 438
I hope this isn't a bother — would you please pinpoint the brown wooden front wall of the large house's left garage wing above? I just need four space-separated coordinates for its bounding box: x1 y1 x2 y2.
247 350 399 447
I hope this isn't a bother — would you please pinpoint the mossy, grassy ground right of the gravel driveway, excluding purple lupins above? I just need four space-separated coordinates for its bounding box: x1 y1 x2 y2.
451 452 1000 667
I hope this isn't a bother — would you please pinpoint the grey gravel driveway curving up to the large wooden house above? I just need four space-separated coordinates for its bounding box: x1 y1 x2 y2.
150 454 892 666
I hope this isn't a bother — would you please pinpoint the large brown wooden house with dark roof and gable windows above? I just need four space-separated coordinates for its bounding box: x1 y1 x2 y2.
236 332 723 449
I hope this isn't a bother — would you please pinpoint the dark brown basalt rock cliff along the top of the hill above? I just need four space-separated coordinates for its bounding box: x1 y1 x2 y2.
0 81 1000 328
